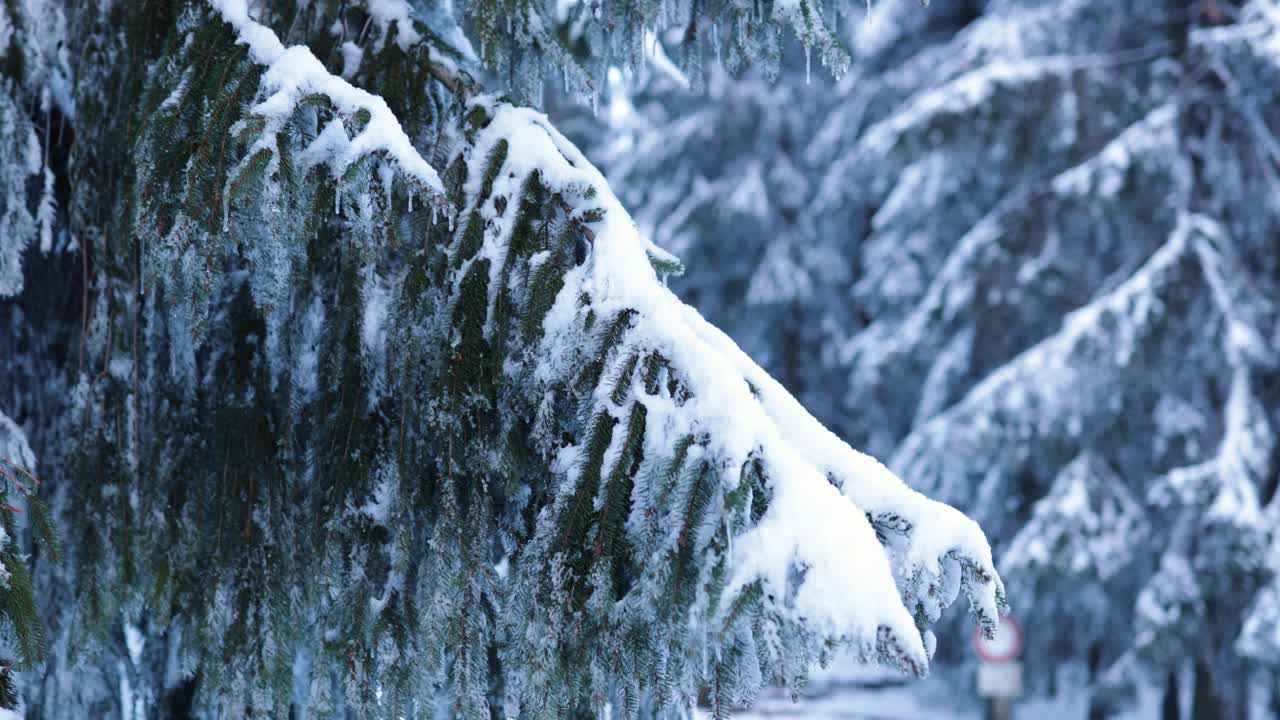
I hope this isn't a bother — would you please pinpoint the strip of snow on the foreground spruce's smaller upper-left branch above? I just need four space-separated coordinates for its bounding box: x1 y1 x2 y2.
210 0 444 196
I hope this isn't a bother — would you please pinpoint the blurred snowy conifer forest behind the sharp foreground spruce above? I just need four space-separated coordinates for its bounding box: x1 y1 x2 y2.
548 0 1280 720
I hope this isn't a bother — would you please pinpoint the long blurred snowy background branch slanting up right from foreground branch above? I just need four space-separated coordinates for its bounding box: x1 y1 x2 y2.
891 213 1253 523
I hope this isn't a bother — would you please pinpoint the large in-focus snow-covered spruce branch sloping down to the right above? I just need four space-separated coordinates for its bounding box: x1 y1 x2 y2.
456 99 1002 673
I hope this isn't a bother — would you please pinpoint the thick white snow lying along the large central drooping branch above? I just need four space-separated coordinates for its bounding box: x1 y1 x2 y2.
458 97 1004 674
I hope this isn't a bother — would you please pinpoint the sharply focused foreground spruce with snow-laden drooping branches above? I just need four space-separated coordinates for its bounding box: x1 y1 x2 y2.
0 0 1005 717
